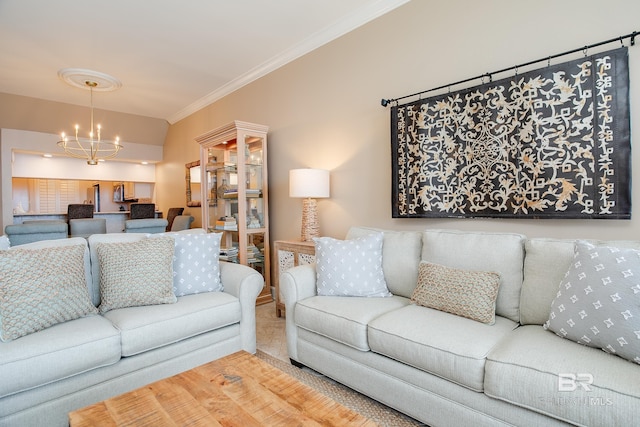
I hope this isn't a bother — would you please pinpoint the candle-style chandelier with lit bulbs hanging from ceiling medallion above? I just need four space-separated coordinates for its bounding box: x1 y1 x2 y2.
58 70 123 165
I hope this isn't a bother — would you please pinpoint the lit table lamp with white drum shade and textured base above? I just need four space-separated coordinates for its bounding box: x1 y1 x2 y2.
289 169 329 242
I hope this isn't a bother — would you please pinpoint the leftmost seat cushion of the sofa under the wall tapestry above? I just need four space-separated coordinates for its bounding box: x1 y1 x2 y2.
294 296 409 351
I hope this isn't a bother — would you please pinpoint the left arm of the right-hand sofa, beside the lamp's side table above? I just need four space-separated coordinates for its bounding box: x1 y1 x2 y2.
280 264 316 360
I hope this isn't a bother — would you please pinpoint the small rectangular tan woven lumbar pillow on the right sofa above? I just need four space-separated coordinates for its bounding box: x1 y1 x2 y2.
411 261 500 325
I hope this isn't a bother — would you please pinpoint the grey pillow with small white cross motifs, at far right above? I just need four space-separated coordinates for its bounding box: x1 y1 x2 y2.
544 242 640 364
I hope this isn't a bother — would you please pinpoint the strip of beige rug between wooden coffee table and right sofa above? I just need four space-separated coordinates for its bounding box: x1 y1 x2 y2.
256 350 425 427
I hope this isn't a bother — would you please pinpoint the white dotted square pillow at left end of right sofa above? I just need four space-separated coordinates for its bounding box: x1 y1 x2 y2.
313 233 391 297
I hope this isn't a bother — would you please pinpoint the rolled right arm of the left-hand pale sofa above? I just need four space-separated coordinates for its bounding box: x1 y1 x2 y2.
220 262 264 354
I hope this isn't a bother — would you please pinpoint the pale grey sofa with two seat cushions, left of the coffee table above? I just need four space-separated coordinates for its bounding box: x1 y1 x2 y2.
0 230 264 426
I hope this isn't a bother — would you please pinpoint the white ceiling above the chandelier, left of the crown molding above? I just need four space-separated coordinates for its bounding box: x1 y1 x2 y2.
0 0 409 123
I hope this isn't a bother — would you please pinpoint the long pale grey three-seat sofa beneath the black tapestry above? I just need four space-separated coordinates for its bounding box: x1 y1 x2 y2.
280 227 640 426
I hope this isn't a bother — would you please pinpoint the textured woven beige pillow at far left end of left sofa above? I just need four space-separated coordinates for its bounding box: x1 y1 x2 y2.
0 244 98 341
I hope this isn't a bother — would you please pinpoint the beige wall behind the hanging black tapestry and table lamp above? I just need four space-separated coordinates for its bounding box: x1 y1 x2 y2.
157 0 640 244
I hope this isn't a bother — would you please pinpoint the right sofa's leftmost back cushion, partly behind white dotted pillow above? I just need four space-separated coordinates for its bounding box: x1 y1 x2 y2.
346 227 422 298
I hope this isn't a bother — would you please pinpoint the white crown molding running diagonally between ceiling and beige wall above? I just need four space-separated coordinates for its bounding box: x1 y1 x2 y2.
167 0 410 124
